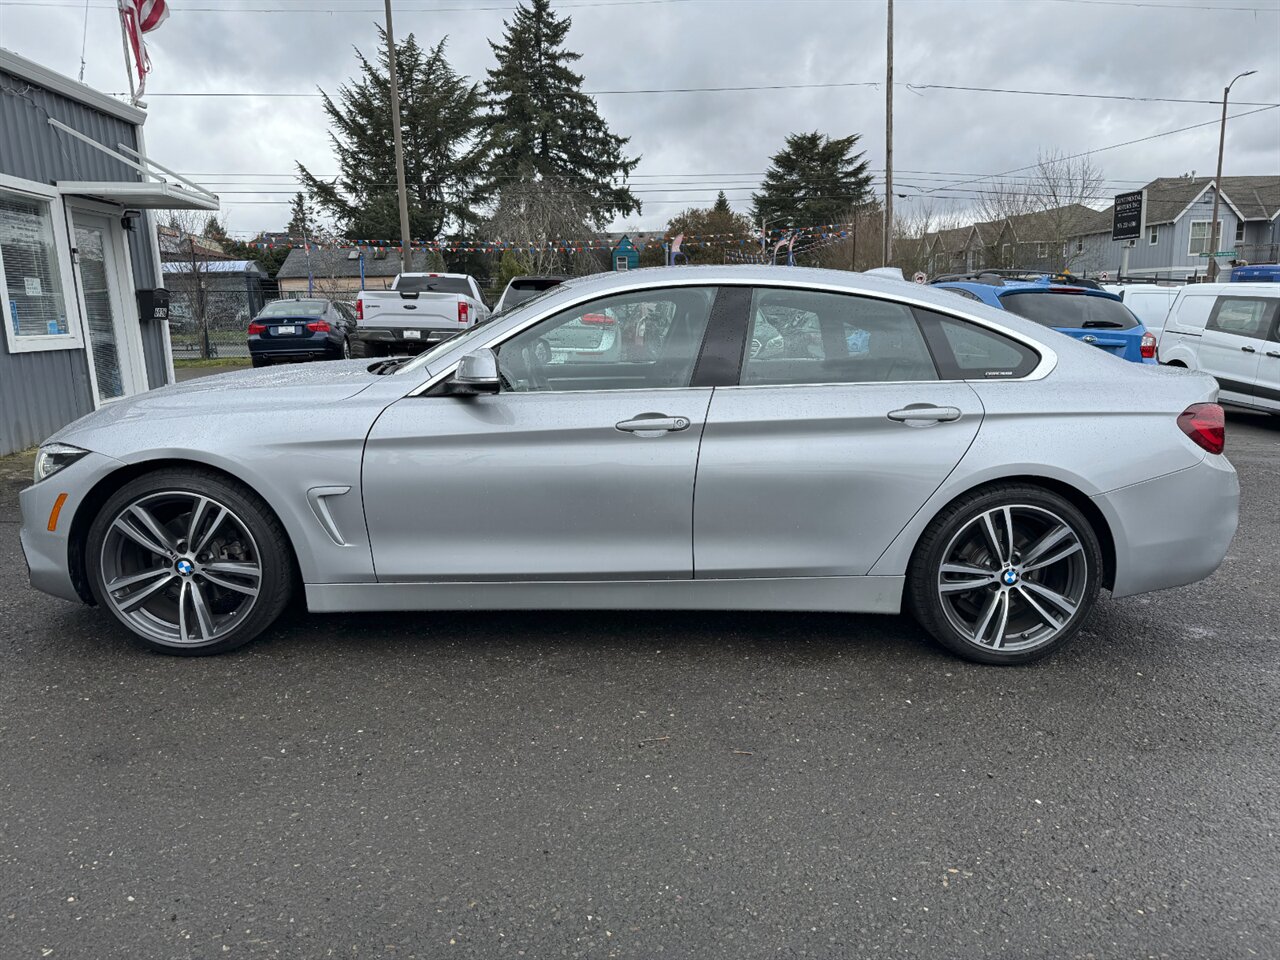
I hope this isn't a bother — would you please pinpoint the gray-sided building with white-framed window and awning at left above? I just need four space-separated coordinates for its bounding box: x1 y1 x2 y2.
0 49 218 454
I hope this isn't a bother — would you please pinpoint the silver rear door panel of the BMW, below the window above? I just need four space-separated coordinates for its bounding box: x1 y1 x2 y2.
694 381 982 579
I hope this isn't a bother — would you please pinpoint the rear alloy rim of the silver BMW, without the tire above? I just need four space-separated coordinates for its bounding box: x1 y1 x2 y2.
937 503 1089 653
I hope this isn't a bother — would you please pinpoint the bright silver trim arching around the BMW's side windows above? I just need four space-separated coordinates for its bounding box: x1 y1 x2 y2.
404 276 1057 397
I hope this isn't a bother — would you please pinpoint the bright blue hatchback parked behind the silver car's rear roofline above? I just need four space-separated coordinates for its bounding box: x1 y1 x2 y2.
933 274 1158 364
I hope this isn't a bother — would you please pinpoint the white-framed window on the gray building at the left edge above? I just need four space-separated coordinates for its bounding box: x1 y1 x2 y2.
0 191 72 349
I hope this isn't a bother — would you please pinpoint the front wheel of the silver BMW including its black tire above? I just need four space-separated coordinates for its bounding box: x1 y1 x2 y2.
84 468 293 655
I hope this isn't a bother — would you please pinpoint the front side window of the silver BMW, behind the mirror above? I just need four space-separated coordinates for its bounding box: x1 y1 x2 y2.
498 287 716 393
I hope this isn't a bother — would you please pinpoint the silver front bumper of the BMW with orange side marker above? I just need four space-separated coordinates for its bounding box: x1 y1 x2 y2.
18 453 124 602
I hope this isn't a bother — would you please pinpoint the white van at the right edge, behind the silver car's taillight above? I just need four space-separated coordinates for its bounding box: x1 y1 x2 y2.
1160 283 1280 413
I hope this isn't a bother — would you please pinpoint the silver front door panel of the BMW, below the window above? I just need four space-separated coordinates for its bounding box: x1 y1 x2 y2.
364 388 712 581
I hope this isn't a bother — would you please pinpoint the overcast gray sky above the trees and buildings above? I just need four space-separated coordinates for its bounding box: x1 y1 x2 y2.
0 0 1280 236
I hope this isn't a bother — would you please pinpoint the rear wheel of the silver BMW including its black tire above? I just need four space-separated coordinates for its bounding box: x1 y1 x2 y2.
906 484 1102 666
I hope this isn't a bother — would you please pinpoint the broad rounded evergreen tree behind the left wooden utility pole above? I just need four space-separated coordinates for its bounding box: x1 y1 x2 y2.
291 28 481 239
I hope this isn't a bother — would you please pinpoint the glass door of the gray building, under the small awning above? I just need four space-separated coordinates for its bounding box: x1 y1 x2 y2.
72 211 146 404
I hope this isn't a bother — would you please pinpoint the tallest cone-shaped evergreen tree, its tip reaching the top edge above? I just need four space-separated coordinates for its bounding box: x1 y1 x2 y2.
485 0 640 227
